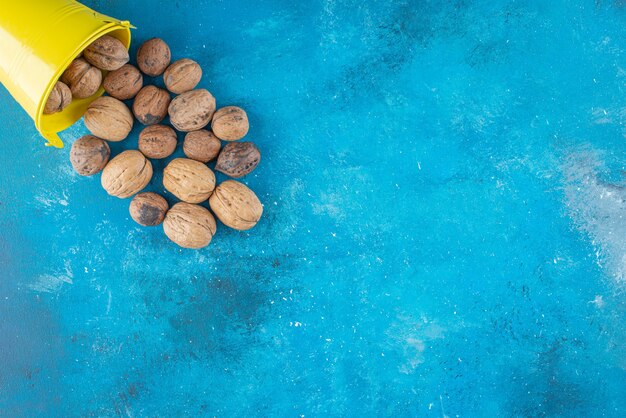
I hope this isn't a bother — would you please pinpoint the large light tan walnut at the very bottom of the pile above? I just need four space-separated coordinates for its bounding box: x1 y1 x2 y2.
163 202 217 249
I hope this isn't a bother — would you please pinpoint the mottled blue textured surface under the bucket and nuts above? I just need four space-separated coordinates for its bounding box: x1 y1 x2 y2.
0 0 626 417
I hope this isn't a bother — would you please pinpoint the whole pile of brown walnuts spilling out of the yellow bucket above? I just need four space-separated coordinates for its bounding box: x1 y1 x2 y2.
66 36 263 248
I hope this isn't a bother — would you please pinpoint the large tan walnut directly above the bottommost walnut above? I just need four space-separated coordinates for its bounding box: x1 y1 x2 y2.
163 158 215 203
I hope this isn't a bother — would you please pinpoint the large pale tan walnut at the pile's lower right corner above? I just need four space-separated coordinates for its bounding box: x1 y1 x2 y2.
209 180 263 231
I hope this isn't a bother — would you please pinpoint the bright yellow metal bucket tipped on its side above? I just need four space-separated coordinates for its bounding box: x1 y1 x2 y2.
0 0 131 148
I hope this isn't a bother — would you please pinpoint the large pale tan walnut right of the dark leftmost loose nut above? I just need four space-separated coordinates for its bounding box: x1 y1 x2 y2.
101 150 152 199
